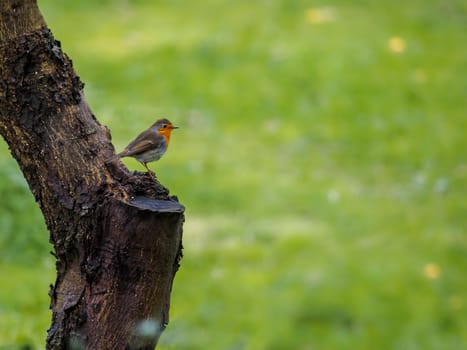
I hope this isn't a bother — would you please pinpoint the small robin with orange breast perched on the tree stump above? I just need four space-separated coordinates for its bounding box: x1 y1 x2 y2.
117 118 178 176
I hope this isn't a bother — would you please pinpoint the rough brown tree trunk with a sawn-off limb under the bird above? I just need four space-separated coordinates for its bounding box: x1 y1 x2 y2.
0 0 184 350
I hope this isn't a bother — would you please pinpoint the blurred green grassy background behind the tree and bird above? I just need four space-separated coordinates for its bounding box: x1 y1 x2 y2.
0 0 467 350
